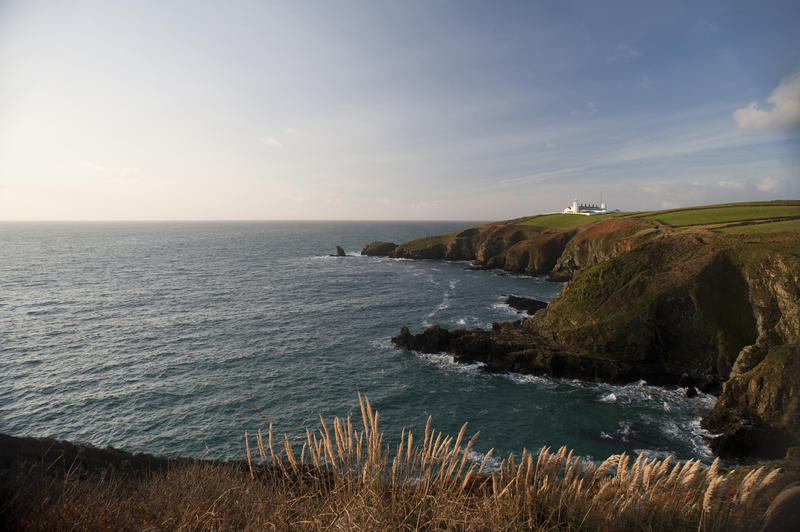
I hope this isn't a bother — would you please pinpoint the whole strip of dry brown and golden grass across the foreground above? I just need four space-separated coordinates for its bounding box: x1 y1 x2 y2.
0 392 787 531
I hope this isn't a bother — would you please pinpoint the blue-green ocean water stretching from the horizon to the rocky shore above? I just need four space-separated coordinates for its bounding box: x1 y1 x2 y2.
0 222 715 461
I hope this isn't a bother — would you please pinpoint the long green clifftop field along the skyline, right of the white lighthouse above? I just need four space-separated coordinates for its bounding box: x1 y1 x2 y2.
635 202 800 227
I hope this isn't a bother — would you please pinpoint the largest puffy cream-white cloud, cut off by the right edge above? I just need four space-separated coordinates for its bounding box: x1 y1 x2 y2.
733 70 800 131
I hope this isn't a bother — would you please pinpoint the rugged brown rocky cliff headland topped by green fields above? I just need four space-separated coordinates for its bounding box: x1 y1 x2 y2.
368 201 800 456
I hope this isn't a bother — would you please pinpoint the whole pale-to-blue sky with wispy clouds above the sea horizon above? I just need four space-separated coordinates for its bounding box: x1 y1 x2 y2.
0 0 800 221
